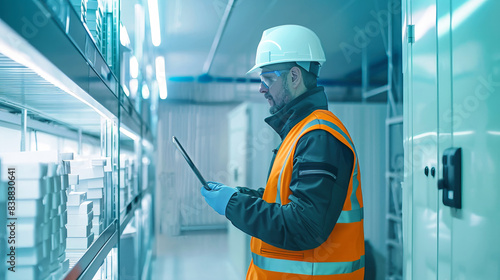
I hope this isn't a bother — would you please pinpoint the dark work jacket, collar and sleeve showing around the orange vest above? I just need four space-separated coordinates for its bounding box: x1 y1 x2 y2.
226 87 354 251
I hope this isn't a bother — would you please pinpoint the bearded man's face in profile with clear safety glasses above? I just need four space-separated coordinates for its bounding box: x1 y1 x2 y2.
259 68 291 115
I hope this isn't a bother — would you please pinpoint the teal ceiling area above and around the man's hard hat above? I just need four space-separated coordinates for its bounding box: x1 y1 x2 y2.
158 0 399 80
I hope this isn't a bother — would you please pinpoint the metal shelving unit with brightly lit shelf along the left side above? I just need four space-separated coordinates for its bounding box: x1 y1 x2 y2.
0 0 154 279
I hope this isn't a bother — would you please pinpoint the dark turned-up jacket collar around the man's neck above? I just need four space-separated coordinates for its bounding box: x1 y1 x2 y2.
265 87 328 140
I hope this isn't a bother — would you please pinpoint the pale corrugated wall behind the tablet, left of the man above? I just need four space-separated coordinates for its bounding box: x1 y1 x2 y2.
156 102 238 234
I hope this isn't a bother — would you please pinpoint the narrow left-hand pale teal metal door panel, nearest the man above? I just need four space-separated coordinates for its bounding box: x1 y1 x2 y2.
403 0 440 279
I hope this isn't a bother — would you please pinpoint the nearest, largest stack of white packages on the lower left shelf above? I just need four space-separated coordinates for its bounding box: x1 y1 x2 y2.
0 152 72 279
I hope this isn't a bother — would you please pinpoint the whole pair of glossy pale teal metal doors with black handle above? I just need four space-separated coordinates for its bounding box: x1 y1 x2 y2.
403 0 500 279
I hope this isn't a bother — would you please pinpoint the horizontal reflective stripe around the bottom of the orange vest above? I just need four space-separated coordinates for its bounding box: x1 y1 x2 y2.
252 253 365 275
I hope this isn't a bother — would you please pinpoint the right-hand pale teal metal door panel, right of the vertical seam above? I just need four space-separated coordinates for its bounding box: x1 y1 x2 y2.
438 0 500 279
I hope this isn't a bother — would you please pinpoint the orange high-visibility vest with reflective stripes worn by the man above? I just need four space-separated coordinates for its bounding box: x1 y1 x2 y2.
246 110 365 280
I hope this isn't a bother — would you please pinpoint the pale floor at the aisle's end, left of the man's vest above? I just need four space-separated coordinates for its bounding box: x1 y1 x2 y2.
151 230 240 280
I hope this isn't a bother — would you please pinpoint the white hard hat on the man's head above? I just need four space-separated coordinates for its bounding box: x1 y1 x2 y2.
247 25 326 74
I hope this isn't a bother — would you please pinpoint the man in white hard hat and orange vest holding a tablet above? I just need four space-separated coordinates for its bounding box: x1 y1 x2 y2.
201 25 364 280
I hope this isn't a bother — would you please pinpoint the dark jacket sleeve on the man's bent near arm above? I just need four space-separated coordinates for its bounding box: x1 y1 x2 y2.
226 130 354 251
